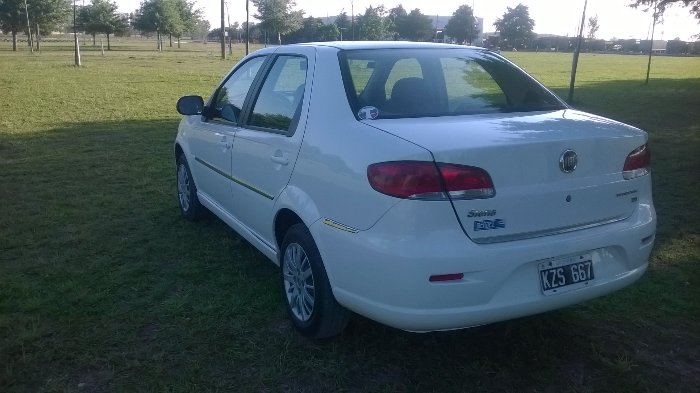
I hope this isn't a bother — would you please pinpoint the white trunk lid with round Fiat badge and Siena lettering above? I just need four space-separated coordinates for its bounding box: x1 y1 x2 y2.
367 110 646 243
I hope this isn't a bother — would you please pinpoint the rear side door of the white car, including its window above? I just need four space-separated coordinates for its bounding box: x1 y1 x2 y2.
231 47 315 248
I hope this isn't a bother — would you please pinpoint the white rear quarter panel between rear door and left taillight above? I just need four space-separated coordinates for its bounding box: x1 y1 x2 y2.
289 47 432 230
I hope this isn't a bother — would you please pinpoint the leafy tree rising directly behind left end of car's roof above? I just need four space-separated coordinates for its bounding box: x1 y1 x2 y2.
253 0 304 45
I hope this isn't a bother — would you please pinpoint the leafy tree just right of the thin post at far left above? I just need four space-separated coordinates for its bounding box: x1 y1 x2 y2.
78 0 129 50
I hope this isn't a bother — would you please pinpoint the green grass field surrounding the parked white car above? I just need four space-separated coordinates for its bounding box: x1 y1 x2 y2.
0 40 700 392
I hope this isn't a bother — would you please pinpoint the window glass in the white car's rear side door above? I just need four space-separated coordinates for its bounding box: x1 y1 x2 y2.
248 56 307 132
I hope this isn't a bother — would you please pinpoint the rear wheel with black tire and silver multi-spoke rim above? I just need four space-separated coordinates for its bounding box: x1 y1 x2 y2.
280 224 350 339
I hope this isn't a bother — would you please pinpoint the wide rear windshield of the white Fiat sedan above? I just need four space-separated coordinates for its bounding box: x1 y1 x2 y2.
339 49 565 119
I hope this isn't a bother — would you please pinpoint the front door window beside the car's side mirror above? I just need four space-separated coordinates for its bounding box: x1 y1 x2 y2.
212 56 265 123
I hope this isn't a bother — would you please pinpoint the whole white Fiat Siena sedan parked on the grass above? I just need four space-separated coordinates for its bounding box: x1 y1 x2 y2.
174 42 656 338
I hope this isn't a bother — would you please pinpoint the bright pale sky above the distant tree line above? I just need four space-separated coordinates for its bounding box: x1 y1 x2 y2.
116 0 700 41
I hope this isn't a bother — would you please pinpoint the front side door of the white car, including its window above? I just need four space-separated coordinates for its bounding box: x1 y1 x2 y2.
189 56 266 213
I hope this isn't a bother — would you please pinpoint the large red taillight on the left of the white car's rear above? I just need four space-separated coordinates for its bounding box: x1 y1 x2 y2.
367 161 496 200
